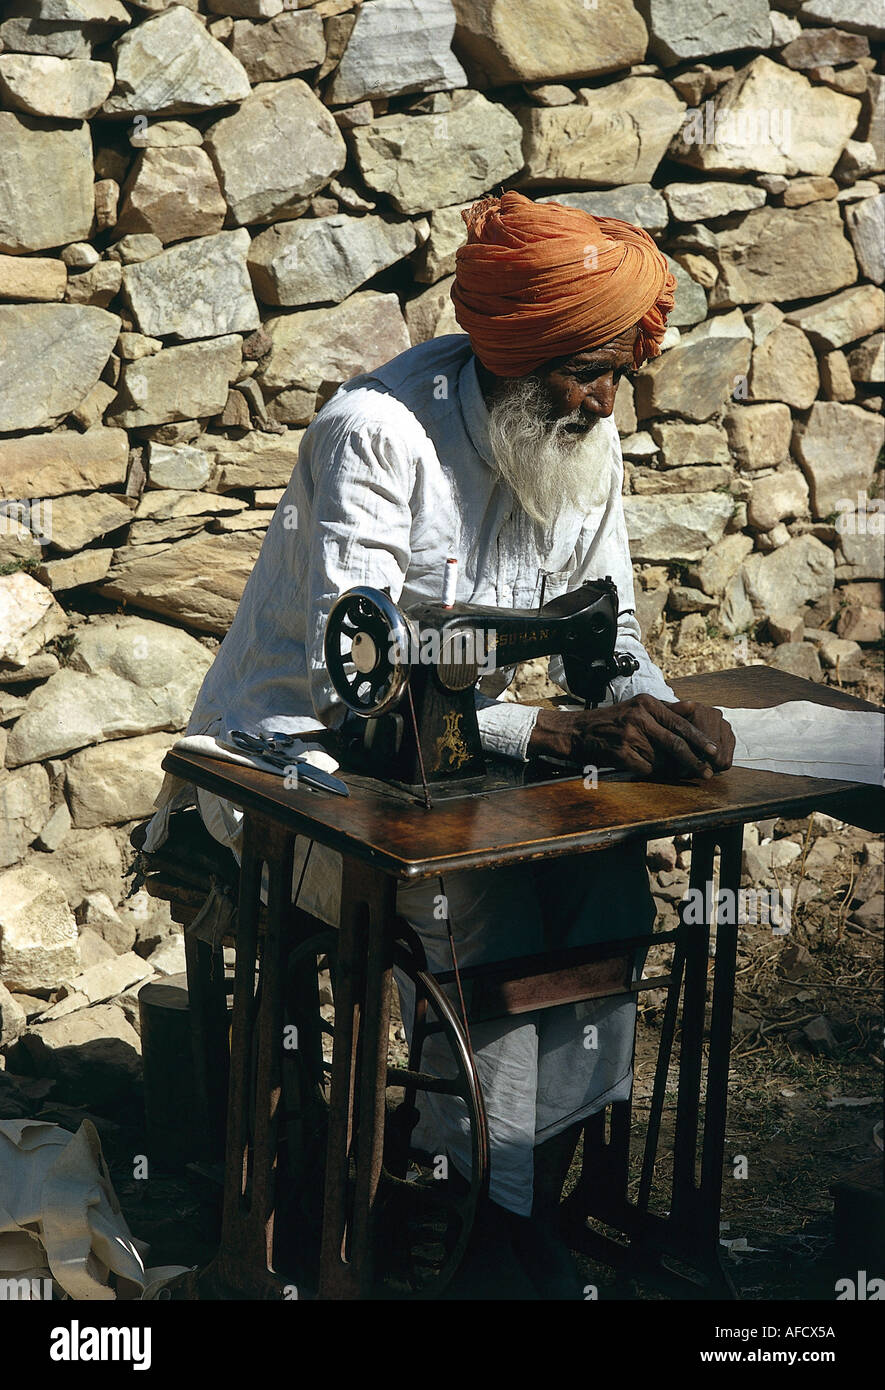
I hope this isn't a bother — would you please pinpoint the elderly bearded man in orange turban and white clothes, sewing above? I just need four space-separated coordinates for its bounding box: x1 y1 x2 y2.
150 192 734 1294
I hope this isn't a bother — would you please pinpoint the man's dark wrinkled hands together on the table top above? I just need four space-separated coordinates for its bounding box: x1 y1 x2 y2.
528 695 735 780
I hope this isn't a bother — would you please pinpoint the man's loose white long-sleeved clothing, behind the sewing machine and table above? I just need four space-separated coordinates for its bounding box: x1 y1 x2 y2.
154 335 675 1215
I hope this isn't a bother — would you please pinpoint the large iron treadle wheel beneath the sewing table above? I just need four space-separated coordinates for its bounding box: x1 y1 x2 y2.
275 930 489 1298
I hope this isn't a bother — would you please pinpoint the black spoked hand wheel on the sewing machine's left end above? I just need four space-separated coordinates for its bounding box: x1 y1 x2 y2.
324 585 413 719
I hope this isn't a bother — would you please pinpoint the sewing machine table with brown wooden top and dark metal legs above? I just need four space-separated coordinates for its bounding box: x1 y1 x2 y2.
163 666 884 1298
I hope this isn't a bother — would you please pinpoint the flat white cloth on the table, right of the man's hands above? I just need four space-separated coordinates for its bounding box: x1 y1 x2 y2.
722 699 885 787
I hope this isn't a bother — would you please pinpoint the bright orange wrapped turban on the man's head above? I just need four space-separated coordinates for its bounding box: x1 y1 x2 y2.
452 192 677 377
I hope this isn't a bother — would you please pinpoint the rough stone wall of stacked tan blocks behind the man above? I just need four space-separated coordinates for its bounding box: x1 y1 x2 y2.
0 0 885 1045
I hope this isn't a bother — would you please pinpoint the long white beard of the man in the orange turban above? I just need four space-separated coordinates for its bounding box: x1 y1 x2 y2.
489 377 615 527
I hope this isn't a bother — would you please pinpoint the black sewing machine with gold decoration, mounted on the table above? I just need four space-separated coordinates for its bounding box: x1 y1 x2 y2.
325 577 638 799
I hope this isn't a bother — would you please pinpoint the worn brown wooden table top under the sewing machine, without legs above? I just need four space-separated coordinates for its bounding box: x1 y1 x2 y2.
163 666 885 880
